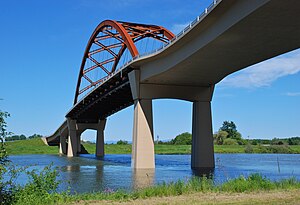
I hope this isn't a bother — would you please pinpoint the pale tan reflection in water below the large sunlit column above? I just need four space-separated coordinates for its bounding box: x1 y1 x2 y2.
132 169 155 189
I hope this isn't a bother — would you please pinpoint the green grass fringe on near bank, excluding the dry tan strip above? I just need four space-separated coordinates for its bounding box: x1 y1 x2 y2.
10 174 300 205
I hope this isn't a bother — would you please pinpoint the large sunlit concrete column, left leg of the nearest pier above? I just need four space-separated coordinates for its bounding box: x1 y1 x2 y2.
131 99 155 169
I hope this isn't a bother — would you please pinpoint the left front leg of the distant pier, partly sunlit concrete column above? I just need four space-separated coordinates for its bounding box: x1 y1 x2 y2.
67 119 78 157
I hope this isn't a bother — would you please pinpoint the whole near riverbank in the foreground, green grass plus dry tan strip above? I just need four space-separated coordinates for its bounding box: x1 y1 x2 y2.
11 174 300 205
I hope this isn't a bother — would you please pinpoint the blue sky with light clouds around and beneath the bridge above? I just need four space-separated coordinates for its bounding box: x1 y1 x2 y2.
0 0 300 141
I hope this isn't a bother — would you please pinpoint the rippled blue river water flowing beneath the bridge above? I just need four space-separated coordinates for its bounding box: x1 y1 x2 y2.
9 154 300 193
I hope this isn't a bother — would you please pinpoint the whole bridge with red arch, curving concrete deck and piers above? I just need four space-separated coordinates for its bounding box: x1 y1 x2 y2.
44 0 300 170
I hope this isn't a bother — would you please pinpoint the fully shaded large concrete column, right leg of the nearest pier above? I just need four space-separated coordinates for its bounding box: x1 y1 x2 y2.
191 101 215 171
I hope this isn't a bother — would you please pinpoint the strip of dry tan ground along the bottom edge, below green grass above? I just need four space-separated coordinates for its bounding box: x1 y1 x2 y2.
76 190 300 205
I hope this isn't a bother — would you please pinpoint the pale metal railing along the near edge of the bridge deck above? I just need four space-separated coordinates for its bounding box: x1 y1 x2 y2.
75 0 222 103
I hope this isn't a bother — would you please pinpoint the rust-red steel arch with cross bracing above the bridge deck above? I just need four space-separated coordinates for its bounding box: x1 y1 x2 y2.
74 20 175 104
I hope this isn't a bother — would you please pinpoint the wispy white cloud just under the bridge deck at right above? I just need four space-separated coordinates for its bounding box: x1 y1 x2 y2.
220 49 300 88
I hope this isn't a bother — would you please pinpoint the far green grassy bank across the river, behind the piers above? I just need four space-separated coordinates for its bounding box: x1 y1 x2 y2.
7 139 300 155
